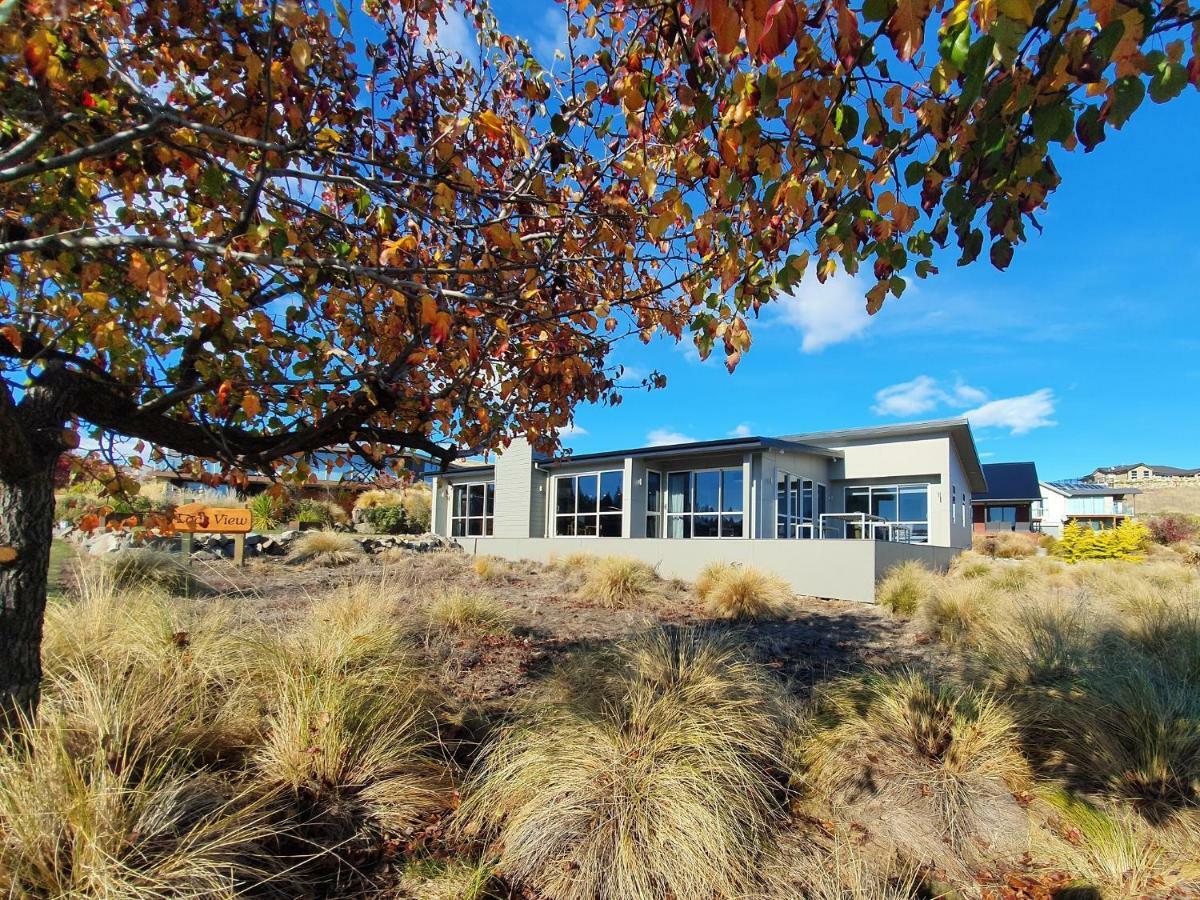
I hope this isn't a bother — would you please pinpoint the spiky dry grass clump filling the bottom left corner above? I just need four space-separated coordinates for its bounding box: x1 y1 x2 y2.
0 710 277 900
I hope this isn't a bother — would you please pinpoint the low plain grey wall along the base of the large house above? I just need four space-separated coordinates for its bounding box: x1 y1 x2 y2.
456 538 958 602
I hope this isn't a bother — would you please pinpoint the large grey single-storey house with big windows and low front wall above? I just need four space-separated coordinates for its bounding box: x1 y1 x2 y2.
433 419 986 600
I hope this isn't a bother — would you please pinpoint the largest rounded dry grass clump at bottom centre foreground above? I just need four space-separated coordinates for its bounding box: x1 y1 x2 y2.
458 630 791 900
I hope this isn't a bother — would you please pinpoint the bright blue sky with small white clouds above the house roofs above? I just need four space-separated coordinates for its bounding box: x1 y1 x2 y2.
463 1 1200 479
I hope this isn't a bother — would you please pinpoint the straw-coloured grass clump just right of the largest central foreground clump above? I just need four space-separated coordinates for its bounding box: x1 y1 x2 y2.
804 672 1030 858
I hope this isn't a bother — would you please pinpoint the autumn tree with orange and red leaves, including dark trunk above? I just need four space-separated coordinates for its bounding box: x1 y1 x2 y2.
0 0 1200 712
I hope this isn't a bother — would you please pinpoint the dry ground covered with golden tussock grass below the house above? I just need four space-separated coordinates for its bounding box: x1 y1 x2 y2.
0 542 1200 900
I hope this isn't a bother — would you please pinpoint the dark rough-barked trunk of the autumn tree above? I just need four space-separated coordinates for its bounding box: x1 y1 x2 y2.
0 457 56 733
